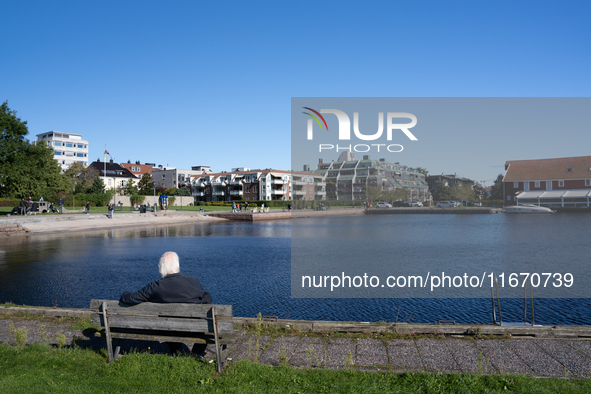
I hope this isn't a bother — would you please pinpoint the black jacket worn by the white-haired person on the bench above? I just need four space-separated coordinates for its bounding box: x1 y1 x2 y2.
119 272 211 305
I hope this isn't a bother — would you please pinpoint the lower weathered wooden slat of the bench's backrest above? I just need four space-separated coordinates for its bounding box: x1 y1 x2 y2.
92 314 234 334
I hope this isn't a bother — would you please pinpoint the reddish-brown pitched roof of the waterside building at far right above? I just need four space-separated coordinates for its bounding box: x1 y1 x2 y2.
503 156 591 182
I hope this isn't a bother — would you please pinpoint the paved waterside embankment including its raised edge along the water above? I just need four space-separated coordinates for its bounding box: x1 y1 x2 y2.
0 306 591 378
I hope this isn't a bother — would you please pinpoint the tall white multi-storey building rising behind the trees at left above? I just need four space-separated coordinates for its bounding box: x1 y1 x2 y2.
37 131 88 171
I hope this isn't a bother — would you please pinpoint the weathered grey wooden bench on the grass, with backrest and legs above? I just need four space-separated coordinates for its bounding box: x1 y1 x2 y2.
90 300 234 373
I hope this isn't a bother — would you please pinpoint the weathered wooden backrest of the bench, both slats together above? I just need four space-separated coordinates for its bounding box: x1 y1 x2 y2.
90 300 234 334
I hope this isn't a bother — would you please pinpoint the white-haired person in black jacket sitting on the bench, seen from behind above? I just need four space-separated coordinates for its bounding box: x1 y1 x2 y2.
119 252 211 356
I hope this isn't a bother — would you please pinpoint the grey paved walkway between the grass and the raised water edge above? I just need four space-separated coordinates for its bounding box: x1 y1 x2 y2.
0 319 591 378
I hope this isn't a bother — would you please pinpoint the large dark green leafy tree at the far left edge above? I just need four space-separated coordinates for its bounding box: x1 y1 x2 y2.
0 102 66 199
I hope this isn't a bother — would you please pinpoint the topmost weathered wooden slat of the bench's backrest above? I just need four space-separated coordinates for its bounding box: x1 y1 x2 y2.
90 300 233 318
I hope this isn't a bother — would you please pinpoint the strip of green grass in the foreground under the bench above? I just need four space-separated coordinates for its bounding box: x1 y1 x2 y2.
0 345 591 394
